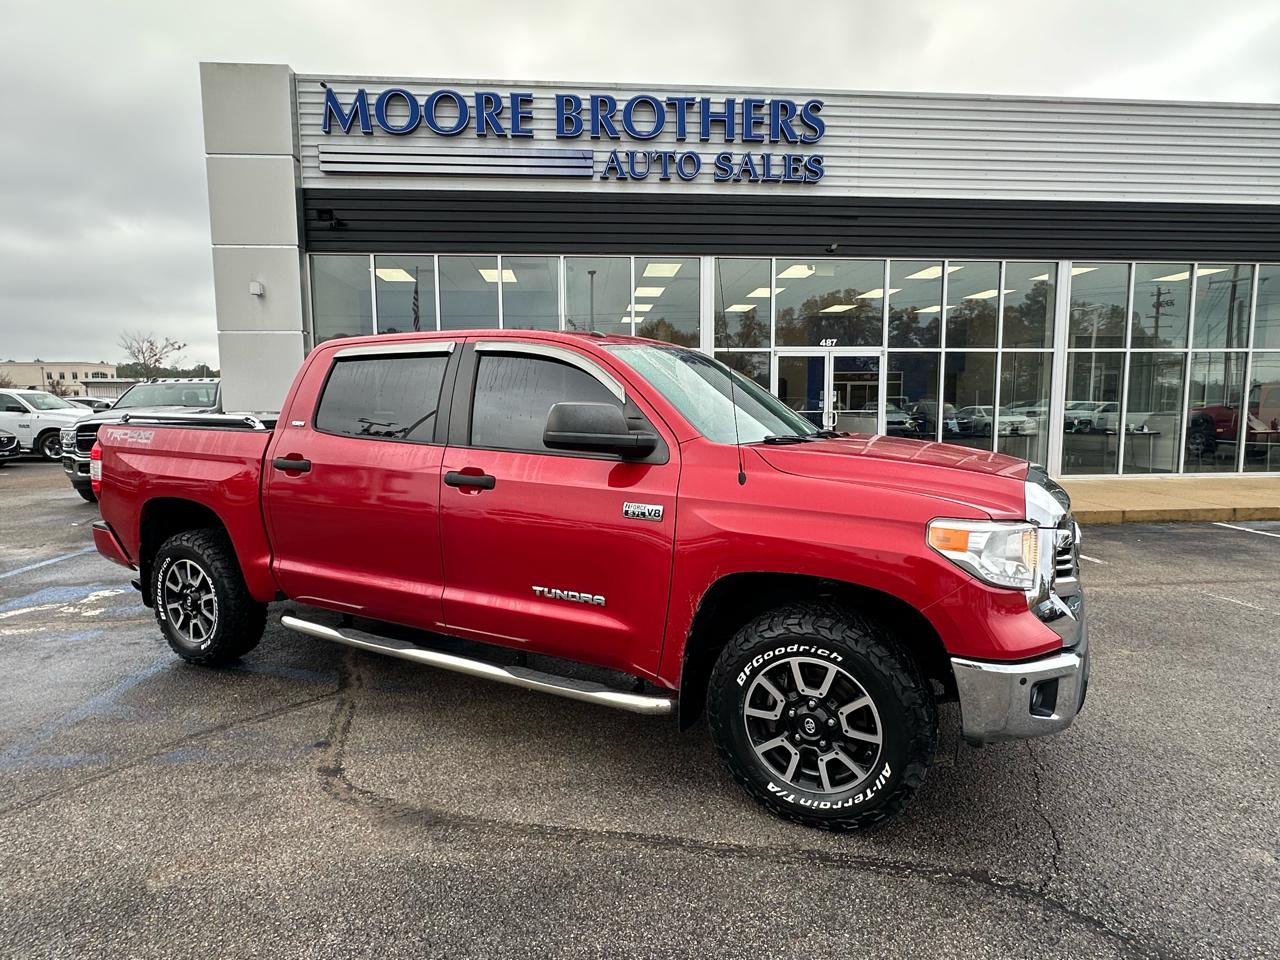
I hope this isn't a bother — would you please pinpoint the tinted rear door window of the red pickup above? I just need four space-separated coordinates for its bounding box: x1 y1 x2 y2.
315 356 448 443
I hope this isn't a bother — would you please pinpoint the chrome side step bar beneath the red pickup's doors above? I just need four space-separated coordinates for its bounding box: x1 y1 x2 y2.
280 616 676 717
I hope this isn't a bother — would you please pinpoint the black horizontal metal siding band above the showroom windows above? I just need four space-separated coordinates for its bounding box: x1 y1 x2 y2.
303 189 1280 261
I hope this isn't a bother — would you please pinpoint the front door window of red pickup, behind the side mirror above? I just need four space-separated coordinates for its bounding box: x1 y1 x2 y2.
471 353 622 453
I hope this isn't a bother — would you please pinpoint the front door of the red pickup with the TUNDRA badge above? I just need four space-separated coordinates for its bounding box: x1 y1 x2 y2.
440 340 680 673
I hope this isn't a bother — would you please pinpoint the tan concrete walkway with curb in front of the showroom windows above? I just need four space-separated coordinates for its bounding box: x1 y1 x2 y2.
1061 474 1280 524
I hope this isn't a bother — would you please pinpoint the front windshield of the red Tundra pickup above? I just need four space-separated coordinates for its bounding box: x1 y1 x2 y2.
608 343 817 443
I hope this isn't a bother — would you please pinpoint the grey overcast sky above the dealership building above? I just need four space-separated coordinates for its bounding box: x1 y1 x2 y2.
0 0 1280 365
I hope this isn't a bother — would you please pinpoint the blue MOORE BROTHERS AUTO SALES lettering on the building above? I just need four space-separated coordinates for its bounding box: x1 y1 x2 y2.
320 86 827 184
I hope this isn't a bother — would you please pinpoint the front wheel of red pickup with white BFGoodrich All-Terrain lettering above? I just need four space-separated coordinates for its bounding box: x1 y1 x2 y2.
708 603 938 829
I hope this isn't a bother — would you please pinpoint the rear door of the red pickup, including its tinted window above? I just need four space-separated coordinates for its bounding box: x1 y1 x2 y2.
264 342 456 628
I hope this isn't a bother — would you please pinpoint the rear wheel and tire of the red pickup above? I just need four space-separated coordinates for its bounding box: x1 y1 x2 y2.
151 529 266 667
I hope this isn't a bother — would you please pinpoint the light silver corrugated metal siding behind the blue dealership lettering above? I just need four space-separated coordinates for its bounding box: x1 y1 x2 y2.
297 76 1280 204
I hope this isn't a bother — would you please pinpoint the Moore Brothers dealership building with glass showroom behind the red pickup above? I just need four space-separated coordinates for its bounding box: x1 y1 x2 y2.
201 63 1280 476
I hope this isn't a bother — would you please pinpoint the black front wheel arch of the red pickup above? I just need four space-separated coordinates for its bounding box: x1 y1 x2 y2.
680 572 955 730
